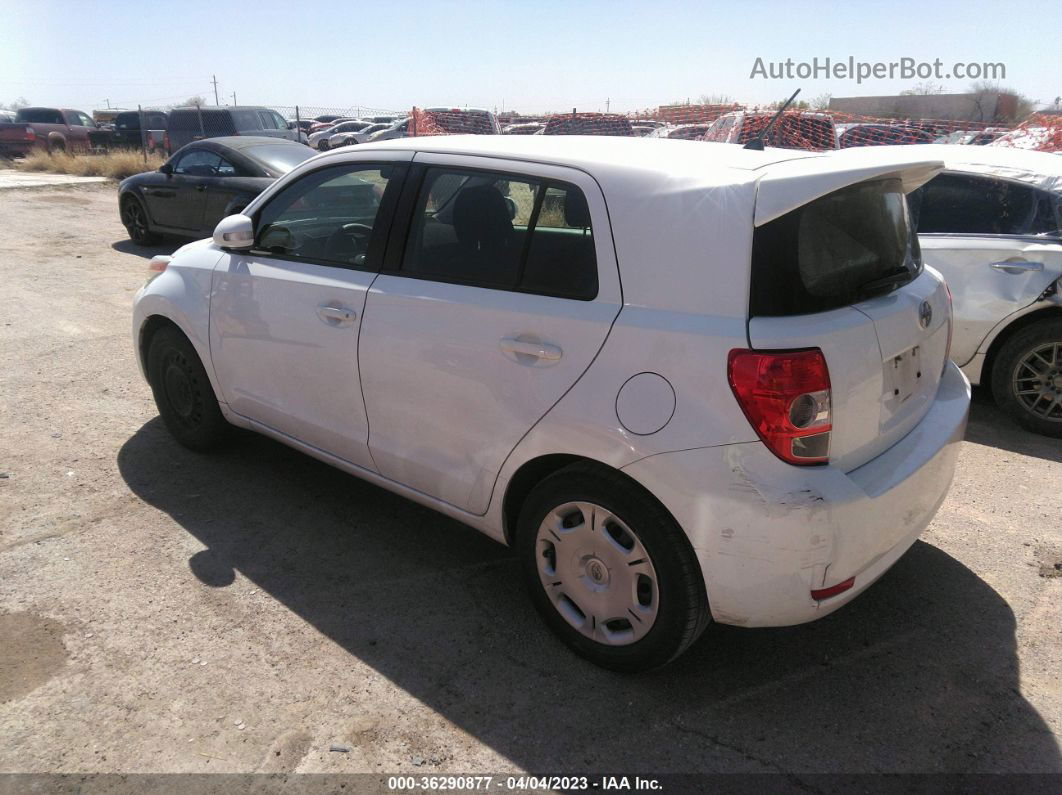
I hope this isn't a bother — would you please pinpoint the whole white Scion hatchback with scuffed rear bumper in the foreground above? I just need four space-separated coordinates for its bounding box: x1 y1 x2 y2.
133 136 970 670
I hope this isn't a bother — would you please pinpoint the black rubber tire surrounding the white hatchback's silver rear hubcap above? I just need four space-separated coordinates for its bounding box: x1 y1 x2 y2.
515 463 710 672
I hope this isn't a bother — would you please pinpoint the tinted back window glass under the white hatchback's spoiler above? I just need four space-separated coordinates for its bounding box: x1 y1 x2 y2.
749 179 922 316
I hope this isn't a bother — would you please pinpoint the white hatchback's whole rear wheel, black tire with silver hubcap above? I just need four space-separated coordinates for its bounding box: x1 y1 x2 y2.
516 464 708 672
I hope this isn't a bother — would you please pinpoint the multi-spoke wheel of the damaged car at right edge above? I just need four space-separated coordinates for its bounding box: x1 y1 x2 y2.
992 319 1062 437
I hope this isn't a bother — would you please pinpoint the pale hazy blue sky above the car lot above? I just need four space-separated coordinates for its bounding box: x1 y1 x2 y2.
0 0 1062 113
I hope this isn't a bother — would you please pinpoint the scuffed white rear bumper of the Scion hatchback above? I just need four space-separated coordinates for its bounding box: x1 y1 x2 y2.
624 362 970 626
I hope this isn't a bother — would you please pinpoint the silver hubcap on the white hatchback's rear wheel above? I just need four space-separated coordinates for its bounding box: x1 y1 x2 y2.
535 502 660 645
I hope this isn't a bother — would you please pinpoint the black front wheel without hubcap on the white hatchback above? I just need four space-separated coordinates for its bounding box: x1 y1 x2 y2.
148 326 232 452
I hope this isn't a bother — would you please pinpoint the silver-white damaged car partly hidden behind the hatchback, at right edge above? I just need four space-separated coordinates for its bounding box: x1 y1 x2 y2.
897 144 1062 436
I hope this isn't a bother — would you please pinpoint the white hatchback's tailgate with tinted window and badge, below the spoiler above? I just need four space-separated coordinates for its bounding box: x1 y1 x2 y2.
749 178 949 471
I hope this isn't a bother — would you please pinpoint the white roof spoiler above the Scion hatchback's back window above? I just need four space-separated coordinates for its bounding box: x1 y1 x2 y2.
755 153 944 226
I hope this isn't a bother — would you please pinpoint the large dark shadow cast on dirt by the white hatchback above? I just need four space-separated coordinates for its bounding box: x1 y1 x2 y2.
118 418 1062 773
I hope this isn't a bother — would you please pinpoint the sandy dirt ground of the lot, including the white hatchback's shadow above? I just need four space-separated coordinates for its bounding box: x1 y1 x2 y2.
0 185 1062 780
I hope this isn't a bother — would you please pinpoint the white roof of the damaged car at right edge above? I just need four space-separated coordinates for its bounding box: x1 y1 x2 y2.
862 143 1062 193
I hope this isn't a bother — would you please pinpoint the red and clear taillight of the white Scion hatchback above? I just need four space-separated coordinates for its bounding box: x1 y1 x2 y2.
726 348 833 464
